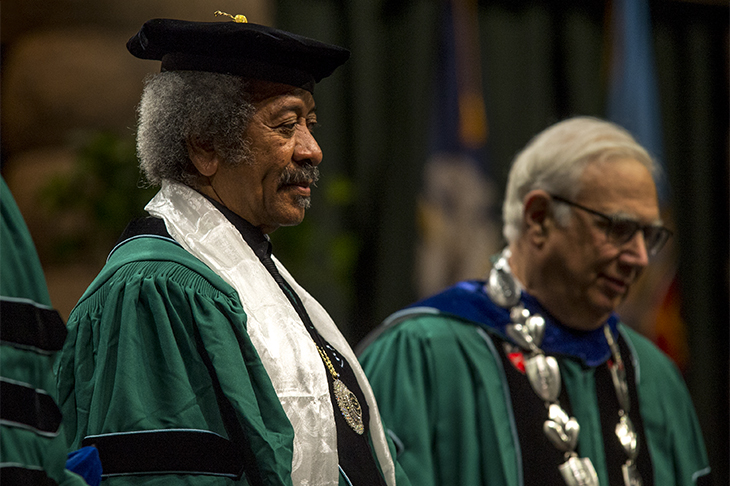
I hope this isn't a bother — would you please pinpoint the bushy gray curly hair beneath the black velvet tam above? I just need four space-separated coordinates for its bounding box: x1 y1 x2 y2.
137 71 254 187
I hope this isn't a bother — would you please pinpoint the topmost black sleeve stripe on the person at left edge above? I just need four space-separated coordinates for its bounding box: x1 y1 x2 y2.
0 298 67 353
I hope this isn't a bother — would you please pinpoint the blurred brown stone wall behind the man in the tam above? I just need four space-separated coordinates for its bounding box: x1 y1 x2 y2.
0 0 274 319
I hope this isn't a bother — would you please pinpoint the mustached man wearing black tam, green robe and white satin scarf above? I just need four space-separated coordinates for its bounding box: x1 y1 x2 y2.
57 15 408 486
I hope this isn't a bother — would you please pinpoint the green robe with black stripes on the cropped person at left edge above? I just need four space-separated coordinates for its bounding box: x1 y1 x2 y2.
0 179 86 485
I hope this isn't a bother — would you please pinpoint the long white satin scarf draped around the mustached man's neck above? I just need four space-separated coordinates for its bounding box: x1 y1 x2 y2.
145 181 395 486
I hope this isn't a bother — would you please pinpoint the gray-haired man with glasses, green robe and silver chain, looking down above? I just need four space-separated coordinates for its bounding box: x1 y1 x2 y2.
360 117 710 486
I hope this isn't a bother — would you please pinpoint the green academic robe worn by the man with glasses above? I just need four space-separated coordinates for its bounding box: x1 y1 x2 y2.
360 302 709 486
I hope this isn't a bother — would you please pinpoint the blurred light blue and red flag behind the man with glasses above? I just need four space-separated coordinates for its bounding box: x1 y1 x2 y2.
606 0 689 369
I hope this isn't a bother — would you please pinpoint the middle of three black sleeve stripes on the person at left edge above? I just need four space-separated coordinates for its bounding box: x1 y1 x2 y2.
0 378 61 436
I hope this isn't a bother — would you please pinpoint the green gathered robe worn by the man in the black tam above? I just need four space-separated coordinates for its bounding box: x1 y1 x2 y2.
57 237 404 485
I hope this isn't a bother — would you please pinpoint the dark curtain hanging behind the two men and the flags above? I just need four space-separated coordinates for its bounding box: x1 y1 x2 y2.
274 0 730 478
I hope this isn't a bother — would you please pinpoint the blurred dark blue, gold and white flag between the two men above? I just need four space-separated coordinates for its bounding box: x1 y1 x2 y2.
416 0 501 296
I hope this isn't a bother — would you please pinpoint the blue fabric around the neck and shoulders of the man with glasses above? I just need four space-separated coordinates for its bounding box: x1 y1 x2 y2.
408 280 618 366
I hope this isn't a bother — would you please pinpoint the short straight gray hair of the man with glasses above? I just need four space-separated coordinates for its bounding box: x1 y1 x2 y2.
502 116 660 243
